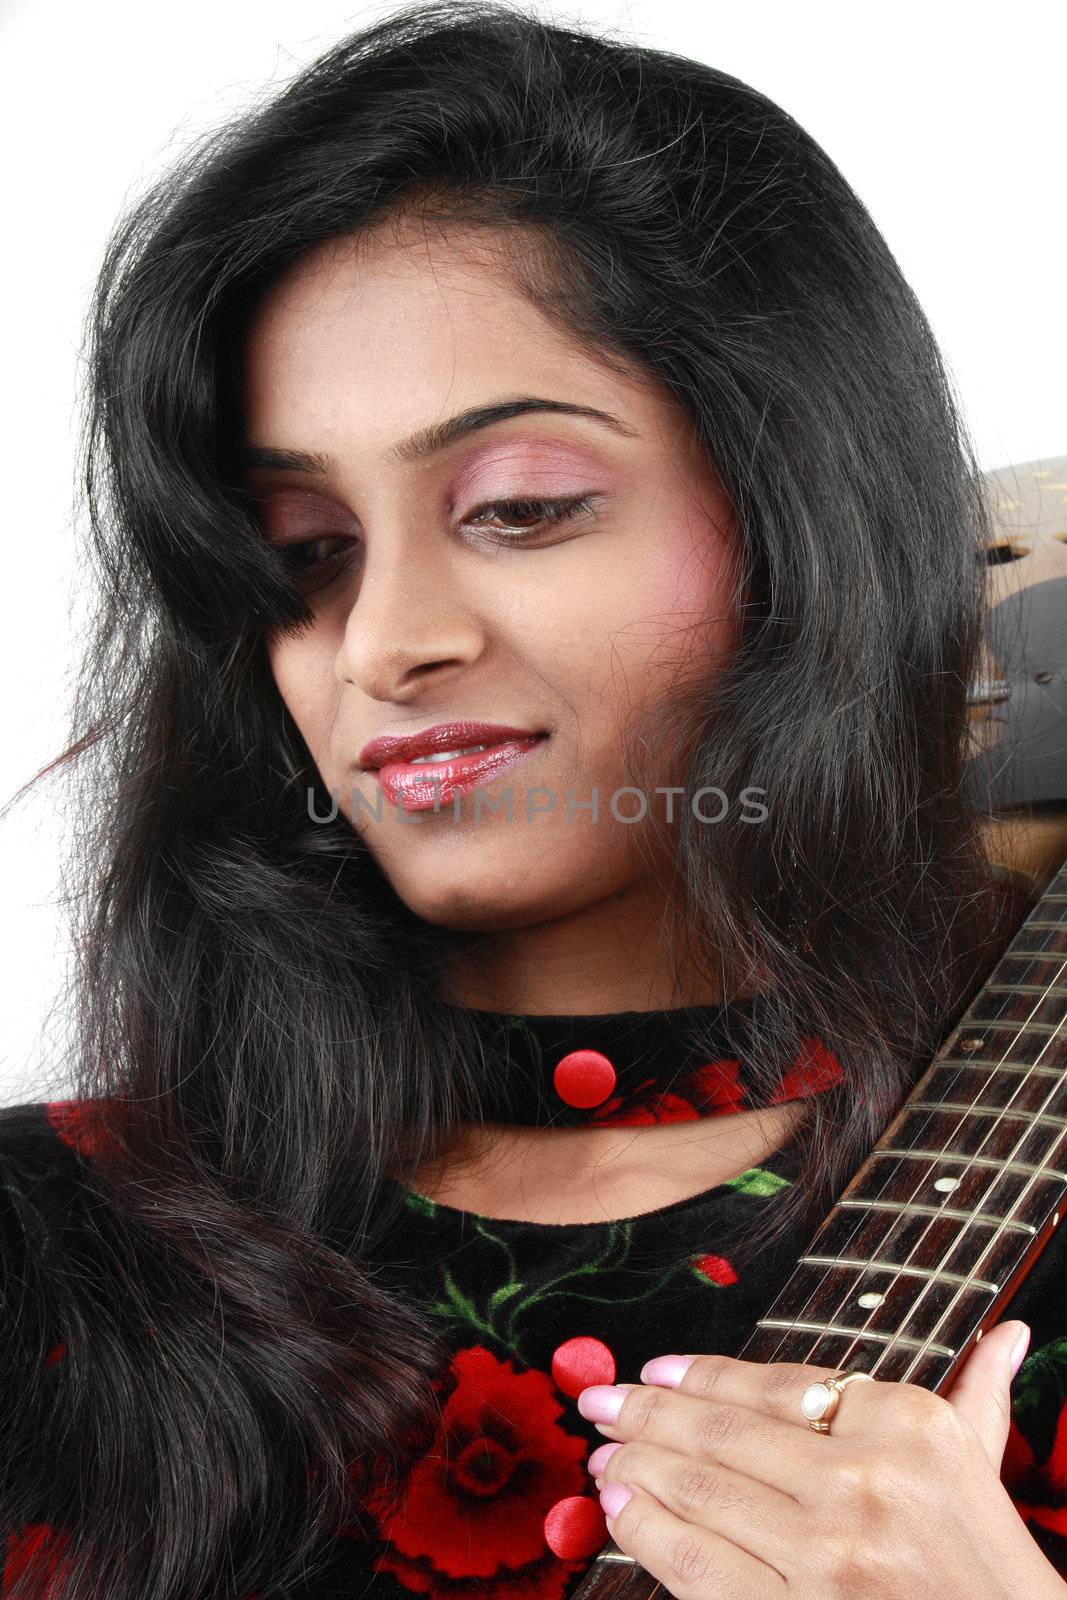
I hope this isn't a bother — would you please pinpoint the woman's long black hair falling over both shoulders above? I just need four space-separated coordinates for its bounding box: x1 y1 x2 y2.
0 0 1017 1600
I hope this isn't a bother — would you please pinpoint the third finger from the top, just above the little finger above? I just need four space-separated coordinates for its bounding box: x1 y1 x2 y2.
595 1440 805 1576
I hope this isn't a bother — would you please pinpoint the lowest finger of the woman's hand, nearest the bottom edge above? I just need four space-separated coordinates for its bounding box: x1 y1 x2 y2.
601 1483 787 1600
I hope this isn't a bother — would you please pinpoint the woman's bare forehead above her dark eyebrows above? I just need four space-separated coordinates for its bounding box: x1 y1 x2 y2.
243 219 694 448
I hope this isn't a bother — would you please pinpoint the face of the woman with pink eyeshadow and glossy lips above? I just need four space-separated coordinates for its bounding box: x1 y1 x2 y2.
245 221 736 1008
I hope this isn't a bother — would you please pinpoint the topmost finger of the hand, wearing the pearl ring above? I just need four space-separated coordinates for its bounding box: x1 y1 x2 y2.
641 1355 883 1435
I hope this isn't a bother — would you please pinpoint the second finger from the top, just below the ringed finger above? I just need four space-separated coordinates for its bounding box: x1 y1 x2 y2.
577 1384 832 1504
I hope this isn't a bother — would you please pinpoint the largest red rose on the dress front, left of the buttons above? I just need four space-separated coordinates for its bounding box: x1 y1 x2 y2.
370 1346 589 1600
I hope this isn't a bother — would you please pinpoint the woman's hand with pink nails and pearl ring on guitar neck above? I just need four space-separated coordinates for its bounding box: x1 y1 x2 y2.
577 1322 1067 1600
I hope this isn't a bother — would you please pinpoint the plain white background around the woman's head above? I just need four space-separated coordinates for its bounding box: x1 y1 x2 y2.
0 0 1067 1102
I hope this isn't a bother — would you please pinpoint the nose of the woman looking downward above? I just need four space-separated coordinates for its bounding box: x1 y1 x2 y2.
336 541 485 701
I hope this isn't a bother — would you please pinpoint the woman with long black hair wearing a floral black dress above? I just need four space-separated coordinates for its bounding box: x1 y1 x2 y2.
0 3 1067 1600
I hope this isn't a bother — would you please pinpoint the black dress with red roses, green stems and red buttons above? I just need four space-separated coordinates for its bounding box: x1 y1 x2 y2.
0 1006 1067 1600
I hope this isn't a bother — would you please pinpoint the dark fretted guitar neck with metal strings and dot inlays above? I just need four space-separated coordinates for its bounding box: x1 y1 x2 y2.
571 864 1067 1600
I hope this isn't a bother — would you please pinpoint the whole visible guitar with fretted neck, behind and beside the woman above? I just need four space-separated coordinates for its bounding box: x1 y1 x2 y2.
571 464 1067 1600
